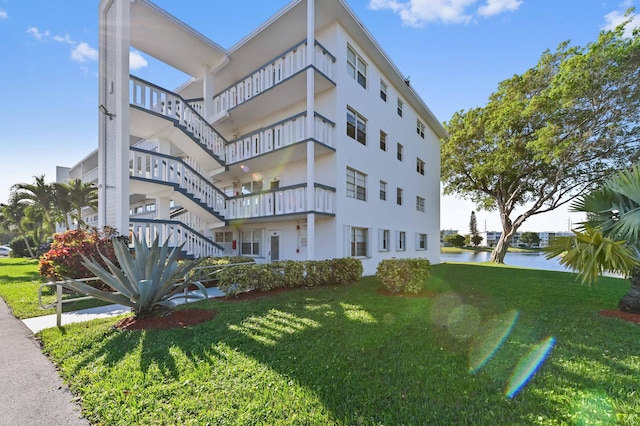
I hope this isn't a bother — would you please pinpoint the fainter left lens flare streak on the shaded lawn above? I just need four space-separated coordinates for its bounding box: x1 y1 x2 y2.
469 310 519 374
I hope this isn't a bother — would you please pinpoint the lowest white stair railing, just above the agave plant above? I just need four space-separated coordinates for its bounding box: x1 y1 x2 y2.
129 220 222 257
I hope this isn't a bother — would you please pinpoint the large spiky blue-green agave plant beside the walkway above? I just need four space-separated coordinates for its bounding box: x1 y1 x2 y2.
62 233 208 318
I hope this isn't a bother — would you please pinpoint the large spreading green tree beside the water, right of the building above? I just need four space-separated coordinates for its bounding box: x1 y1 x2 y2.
442 20 640 263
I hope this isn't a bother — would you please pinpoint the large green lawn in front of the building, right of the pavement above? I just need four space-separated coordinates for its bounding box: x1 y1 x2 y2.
35 264 640 425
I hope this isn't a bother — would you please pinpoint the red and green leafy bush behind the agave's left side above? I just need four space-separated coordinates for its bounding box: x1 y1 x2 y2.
38 226 120 280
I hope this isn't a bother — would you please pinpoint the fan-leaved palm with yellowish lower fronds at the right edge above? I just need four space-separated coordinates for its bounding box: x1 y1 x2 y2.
547 164 640 314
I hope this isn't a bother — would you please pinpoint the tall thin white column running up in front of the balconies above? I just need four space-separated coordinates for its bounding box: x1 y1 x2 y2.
306 0 316 260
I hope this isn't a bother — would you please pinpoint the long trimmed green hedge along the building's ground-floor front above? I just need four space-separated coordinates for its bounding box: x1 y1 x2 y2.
218 258 362 296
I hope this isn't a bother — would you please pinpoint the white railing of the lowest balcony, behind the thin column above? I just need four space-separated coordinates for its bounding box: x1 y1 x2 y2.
225 185 335 219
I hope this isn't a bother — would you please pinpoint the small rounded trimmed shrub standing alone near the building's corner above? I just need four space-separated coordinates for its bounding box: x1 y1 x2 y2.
376 257 431 293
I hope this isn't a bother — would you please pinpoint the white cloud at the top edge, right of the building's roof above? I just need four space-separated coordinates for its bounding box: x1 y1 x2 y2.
369 0 523 27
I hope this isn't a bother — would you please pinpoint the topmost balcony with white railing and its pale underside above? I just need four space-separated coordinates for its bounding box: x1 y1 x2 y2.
209 42 335 130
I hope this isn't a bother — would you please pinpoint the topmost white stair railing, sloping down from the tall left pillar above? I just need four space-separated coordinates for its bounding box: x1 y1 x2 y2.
129 76 226 161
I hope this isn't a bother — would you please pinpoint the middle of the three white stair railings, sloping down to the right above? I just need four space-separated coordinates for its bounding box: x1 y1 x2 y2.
129 149 225 213
